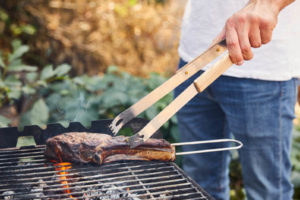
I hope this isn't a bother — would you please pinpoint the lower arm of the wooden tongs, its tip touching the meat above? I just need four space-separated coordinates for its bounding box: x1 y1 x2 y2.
129 52 232 148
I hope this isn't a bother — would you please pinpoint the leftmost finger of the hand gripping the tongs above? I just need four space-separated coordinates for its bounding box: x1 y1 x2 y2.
225 20 244 65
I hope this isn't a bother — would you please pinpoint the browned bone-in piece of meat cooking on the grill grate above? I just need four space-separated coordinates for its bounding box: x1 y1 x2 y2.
45 132 175 165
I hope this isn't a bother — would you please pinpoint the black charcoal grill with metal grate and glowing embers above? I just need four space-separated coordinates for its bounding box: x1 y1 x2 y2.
0 119 212 200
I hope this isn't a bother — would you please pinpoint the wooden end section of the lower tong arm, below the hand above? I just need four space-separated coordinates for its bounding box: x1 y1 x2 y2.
194 52 232 92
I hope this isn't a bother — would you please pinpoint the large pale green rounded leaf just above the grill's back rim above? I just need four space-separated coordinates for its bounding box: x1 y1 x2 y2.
29 99 49 127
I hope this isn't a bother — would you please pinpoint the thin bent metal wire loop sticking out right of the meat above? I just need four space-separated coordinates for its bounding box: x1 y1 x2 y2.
171 139 243 156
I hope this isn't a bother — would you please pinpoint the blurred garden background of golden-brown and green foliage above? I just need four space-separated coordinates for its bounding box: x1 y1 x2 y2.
0 0 300 200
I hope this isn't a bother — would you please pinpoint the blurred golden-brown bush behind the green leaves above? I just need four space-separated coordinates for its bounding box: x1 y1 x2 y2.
0 0 183 76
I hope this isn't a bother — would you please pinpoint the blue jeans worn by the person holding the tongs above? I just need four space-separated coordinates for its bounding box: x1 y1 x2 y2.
175 60 298 200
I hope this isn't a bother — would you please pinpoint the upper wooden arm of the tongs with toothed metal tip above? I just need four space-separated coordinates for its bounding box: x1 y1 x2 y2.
109 40 227 135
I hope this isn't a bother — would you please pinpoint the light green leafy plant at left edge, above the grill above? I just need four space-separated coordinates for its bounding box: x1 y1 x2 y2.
0 40 71 127
